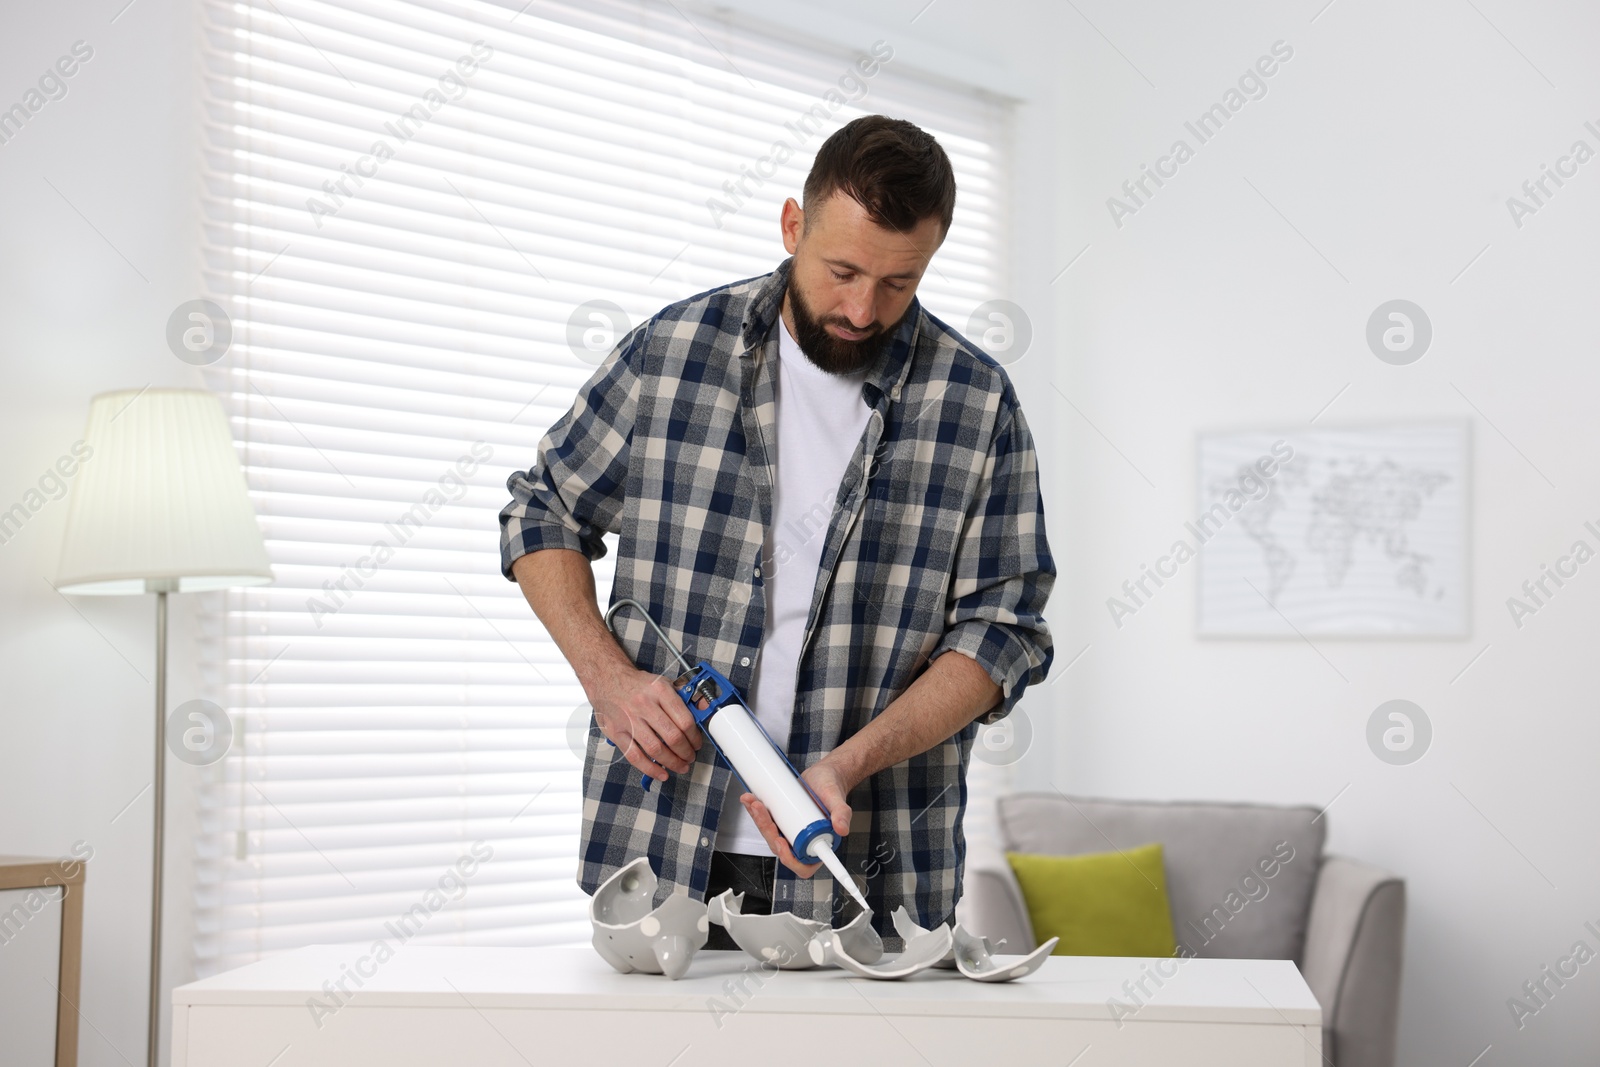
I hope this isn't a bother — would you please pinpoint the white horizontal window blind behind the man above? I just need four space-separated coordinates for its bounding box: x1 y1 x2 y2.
195 0 1006 976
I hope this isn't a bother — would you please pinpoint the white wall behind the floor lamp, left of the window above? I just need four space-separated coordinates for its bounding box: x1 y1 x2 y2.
0 0 200 1067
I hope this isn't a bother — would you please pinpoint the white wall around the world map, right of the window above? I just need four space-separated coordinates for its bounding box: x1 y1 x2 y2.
1036 0 1600 1065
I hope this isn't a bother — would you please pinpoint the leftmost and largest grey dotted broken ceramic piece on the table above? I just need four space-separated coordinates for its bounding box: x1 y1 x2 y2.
589 856 710 979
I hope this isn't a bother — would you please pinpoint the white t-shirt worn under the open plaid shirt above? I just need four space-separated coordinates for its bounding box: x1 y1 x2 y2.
717 315 872 856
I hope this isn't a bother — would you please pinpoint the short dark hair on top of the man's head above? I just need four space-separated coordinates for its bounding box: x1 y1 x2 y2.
803 115 955 240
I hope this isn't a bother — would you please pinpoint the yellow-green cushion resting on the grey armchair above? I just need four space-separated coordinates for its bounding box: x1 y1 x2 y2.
1005 845 1178 957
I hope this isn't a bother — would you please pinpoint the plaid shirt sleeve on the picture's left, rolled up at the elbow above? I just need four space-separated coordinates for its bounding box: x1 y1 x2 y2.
499 323 648 581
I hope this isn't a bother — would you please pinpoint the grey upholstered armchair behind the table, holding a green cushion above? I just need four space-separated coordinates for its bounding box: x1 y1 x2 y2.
958 793 1405 1067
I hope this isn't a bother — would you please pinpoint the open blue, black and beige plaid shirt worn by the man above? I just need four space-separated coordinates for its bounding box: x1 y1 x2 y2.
501 259 1056 949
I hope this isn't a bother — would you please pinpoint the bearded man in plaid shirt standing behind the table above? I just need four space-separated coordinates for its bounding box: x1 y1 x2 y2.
501 115 1054 949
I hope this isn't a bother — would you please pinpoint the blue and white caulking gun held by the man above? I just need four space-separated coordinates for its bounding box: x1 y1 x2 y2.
605 600 870 910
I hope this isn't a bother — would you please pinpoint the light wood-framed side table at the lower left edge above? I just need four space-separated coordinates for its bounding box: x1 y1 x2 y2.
0 856 85 1067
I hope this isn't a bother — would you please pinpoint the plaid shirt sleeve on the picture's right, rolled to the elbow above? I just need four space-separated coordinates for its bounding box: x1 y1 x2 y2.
930 403 1056 725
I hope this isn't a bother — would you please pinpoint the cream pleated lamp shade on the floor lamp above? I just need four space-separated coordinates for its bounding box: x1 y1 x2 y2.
56 389 272 595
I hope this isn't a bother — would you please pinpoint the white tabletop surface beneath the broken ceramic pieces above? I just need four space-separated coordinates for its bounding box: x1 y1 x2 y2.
173 945 1322 1025
